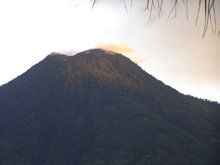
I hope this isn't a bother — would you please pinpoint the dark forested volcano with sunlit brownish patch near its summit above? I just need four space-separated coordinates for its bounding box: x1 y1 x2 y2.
0 49 220 165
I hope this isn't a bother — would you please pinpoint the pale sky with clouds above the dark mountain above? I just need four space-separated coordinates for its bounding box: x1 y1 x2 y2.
0 0 220 103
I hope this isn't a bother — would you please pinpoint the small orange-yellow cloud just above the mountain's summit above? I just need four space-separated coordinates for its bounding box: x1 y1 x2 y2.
96 43 133 53
